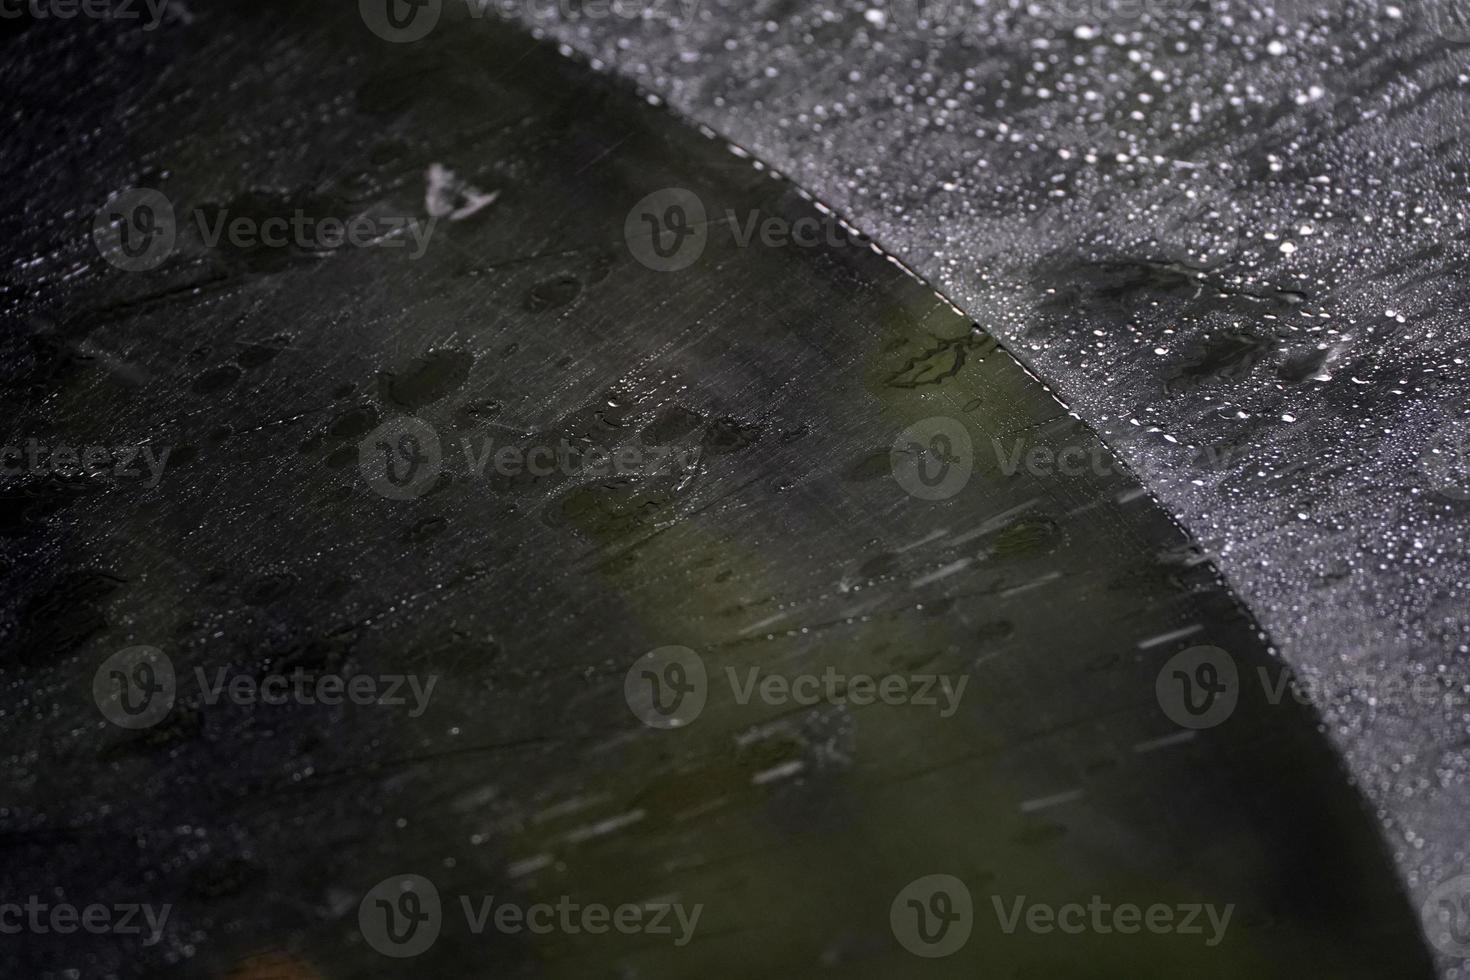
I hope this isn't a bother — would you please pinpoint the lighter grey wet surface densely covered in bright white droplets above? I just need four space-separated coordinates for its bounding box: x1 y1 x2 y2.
496 0 1470 976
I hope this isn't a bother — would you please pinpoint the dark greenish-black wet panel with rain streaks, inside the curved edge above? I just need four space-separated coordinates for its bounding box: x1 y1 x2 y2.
0 4 1430 979
